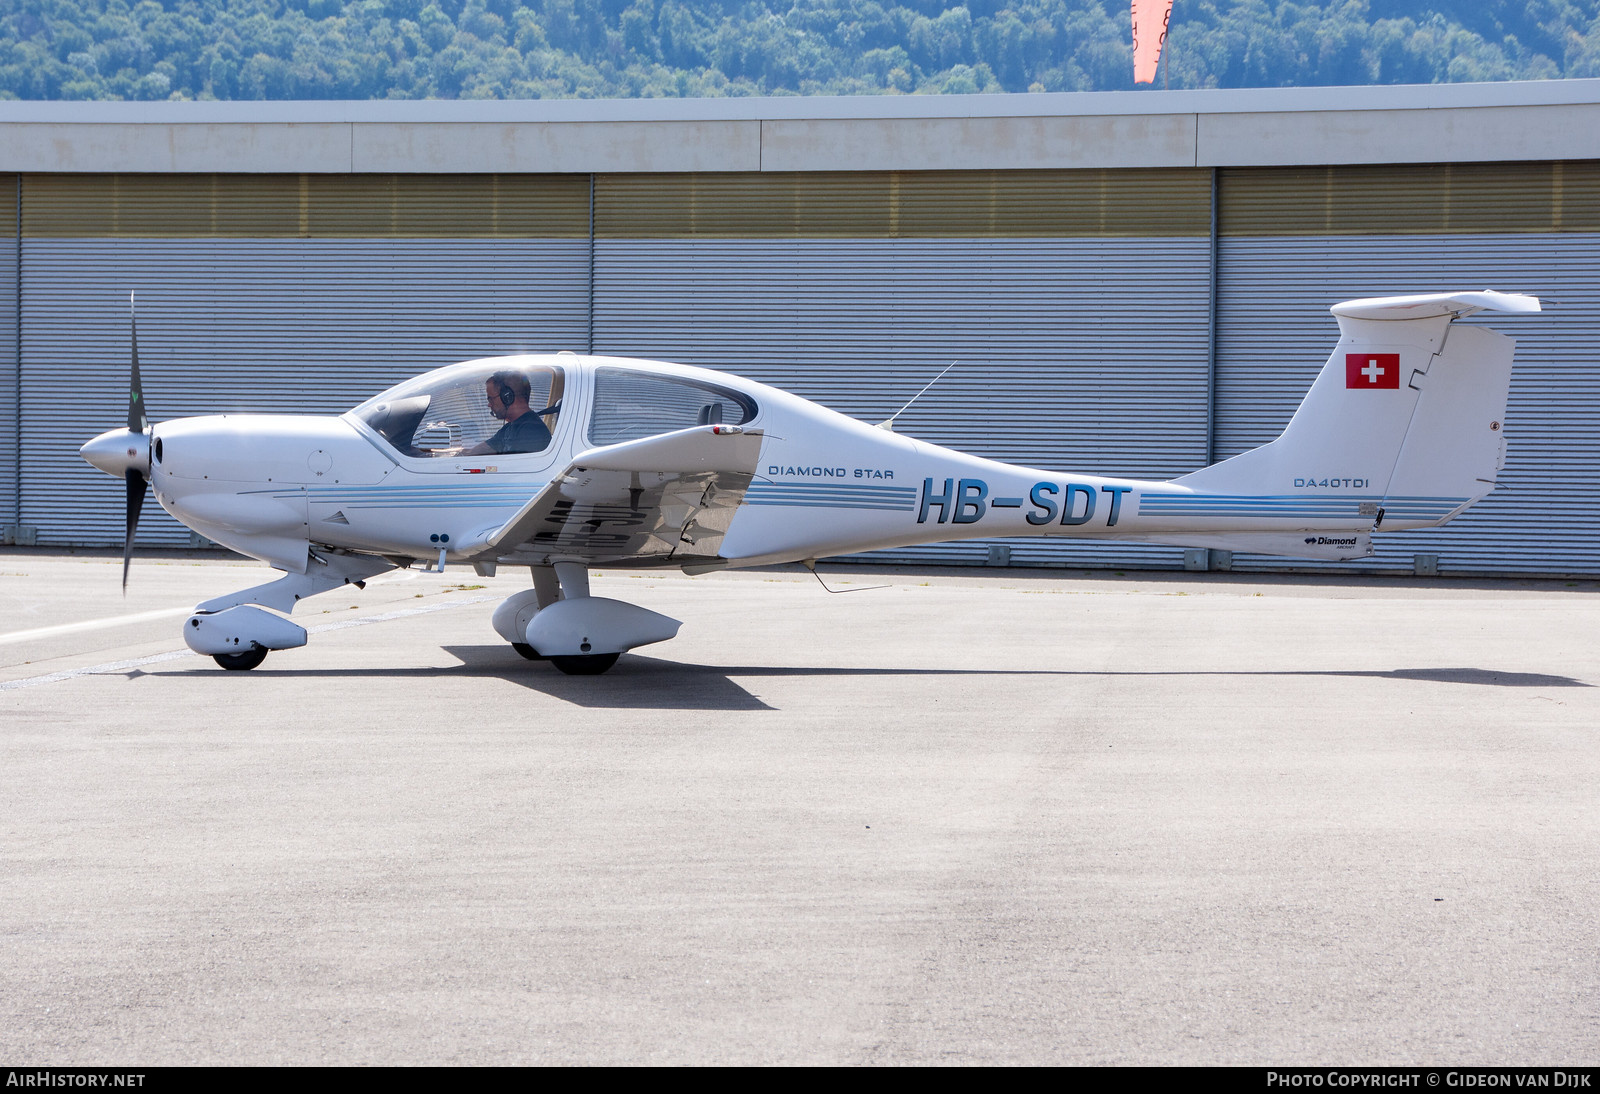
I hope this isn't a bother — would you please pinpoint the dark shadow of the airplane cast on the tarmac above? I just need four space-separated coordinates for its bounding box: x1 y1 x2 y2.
150 645 1594 710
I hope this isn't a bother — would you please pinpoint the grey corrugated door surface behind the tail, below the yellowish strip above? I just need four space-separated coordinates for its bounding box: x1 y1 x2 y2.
1218 235 1600 574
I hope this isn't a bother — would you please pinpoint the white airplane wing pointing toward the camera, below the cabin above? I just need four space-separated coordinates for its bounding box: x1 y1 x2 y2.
478 425 763 568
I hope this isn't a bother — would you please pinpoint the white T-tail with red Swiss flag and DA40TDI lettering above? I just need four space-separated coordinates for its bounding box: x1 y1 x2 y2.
1171 291 1539 558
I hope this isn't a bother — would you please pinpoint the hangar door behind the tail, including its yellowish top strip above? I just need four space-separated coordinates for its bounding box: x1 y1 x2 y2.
1216 163 1600 574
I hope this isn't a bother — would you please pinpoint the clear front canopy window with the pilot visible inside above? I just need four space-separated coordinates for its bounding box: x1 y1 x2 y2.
350 360 565 457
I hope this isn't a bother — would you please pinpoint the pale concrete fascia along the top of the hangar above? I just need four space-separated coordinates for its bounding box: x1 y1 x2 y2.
0 80 1600 173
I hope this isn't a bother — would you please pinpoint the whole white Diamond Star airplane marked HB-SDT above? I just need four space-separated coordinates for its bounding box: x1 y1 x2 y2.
82 291 1539 673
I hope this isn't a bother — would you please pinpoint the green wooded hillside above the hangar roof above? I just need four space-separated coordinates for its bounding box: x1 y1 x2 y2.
0 0 1600 99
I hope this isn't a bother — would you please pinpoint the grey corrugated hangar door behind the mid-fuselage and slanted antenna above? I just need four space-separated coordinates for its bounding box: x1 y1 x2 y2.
595 173 1208 568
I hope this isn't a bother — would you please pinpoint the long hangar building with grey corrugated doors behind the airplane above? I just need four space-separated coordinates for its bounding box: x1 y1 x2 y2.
0 80 1600 574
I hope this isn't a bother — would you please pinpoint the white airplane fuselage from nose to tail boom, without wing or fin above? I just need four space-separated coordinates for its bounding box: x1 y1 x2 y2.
109 353 1401 573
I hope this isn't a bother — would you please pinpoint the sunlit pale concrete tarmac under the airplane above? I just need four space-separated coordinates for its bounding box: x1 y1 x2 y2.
0 550 1600 1065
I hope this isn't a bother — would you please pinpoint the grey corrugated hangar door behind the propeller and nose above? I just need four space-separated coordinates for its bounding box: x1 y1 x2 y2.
22 179 589 545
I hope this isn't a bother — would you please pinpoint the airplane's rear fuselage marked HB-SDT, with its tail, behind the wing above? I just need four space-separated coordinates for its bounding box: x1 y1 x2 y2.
723 293 1539 565
